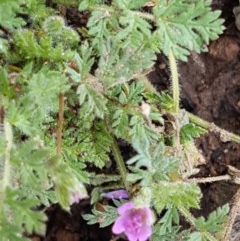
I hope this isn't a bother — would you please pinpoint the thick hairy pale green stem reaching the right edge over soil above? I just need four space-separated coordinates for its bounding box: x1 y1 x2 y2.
188 112 240 143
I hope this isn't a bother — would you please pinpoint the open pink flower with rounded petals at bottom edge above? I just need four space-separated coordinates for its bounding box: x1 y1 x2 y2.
112 202 152 241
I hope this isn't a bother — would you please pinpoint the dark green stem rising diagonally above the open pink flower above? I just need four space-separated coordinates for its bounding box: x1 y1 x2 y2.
112 137 129 192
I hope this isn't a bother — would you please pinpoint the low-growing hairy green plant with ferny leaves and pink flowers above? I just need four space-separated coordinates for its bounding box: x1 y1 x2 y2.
0 0 240 241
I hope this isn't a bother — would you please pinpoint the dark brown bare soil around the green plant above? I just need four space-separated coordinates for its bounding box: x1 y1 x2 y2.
32 0 240 241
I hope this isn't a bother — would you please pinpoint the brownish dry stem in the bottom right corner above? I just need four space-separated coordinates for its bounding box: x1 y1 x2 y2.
222 188 240 241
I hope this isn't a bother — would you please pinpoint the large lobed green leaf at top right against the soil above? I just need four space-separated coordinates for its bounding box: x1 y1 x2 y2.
153 0 224 61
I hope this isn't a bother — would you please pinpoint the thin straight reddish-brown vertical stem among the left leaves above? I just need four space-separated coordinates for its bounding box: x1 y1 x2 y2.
57 93 64 155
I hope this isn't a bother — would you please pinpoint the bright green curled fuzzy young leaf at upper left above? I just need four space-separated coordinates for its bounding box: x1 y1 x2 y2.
12 17 79 62
